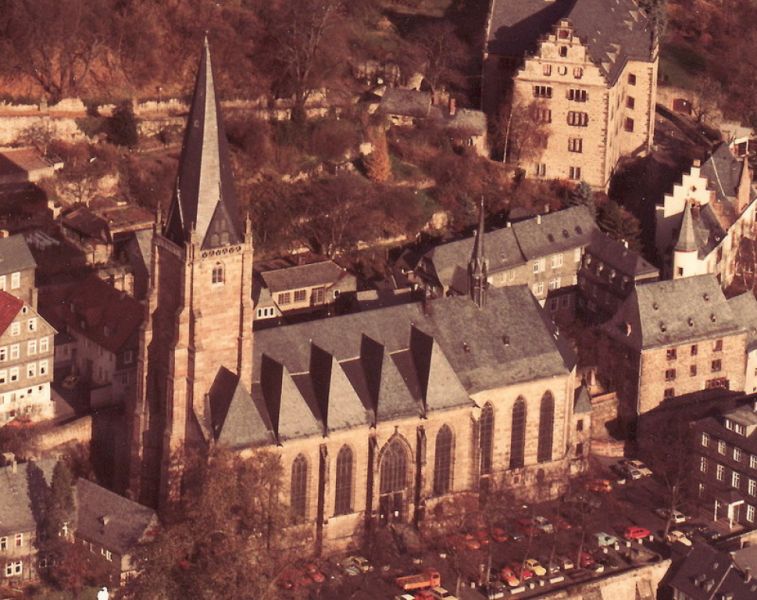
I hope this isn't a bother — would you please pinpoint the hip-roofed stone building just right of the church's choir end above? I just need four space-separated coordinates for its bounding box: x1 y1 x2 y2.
598 275 747 424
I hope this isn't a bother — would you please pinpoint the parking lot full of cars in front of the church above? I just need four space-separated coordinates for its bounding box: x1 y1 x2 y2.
282 459 728 600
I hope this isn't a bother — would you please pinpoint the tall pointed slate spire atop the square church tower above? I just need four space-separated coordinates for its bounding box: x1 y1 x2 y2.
164 36 243 248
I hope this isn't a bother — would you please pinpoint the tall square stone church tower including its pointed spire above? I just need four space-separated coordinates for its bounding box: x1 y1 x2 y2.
129 39 253 506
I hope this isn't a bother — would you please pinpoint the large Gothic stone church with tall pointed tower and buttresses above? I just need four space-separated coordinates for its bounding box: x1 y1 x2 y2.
129 42 585 549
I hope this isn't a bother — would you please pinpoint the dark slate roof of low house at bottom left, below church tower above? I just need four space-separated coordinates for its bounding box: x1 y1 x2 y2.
76 478 158 556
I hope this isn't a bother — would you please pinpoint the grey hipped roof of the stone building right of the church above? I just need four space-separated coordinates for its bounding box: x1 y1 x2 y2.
603 274 745 350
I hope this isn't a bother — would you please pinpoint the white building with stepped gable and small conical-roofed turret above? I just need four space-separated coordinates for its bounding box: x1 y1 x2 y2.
655 144 757 288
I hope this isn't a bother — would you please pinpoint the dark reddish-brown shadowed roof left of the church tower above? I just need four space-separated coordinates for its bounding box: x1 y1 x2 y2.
40 273 144 353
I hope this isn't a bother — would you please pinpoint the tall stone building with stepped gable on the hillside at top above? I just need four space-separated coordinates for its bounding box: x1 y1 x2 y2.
483 0 658 189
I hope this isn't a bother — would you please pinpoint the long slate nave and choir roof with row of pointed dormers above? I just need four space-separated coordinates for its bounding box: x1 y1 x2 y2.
236 286 574 440
